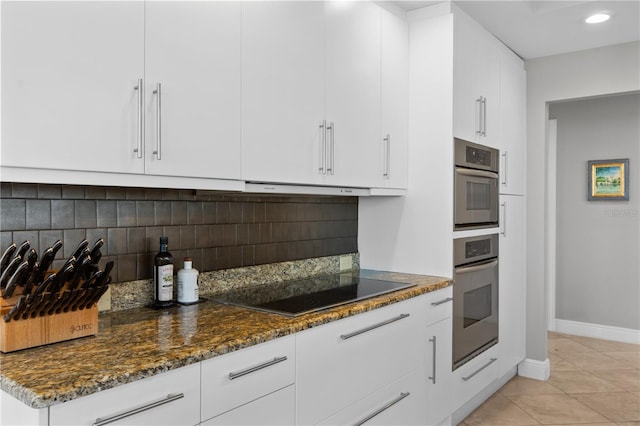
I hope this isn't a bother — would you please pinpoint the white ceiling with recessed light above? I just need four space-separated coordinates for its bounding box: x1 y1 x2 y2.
395 0 640 59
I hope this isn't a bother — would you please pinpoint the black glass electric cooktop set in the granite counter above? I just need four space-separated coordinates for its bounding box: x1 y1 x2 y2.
211 274 415 317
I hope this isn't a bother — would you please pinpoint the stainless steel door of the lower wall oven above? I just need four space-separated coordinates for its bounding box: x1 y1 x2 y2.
453 259 498 369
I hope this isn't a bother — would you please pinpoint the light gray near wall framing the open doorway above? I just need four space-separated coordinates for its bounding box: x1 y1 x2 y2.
525 42 640 361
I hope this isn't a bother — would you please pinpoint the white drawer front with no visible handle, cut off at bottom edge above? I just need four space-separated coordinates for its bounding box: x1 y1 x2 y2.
202 385 296 426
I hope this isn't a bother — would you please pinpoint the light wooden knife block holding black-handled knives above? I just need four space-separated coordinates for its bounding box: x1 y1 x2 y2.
0 295 98 353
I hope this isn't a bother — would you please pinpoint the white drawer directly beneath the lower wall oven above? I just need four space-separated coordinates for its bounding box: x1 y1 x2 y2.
453 345 498 411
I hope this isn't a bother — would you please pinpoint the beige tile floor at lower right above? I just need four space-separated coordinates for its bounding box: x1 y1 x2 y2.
460 332 640 426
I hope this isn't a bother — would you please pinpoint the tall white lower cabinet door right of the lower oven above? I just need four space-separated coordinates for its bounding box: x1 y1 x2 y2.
498 195 526 376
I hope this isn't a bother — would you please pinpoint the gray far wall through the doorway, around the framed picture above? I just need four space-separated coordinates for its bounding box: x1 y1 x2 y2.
549 93 640 329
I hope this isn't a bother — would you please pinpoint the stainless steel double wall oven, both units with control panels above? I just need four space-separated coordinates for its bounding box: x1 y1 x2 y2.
453 138 500 370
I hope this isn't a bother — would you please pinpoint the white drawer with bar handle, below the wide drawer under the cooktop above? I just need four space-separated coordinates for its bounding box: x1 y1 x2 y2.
320 372 428 426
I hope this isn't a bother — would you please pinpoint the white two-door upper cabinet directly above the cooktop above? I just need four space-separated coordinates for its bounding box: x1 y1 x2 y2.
242 1 381 187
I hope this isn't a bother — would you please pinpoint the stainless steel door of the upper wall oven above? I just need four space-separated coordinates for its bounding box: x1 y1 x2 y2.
454 167 499 229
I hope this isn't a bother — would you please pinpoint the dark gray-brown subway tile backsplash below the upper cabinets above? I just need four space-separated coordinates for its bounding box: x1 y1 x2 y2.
0 182 358 282
